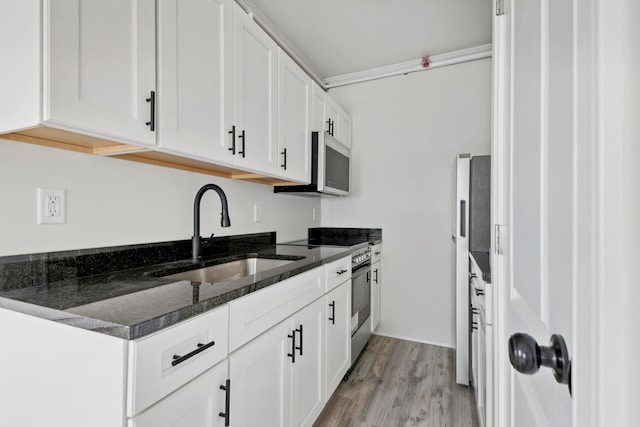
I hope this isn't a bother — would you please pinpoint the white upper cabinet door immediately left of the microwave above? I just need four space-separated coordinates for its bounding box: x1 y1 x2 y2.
278 49 311 184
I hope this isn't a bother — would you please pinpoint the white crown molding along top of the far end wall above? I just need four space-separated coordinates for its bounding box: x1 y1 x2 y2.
323 43 492 89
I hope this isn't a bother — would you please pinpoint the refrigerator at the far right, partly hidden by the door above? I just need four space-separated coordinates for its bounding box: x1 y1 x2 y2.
452 154 491 385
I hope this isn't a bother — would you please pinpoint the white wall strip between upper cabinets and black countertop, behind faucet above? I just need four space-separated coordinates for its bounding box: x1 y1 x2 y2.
0 139 320 256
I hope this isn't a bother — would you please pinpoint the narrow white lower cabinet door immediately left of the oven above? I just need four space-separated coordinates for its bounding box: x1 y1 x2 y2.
324 280 351 399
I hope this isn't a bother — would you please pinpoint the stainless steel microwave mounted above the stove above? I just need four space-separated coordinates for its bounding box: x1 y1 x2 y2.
273 132 351 197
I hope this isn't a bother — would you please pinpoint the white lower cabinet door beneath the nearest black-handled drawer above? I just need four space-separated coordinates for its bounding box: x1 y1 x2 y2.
128 360 230 427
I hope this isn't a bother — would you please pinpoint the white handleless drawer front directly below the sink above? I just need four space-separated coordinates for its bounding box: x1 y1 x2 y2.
229 267 326 352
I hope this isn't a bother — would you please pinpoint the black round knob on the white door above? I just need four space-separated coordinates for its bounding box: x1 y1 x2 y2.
509 333 571 384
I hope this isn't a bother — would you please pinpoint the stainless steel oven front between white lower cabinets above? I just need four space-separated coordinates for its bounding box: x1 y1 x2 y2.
351 246 371 365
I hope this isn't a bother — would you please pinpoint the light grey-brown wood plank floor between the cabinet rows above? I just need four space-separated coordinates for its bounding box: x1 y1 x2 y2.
314 335 478 427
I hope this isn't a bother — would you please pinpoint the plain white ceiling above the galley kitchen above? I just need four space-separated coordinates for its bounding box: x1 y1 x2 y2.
238 0 492 79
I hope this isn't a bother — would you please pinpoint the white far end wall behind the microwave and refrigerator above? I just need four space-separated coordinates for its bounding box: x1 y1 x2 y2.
322 59 491 347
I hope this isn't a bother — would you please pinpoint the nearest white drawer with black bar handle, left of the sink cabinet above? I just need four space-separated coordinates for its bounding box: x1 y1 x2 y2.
127 306 229 417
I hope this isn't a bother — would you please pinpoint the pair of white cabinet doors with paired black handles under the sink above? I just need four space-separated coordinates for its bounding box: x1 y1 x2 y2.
229 298 326 427
